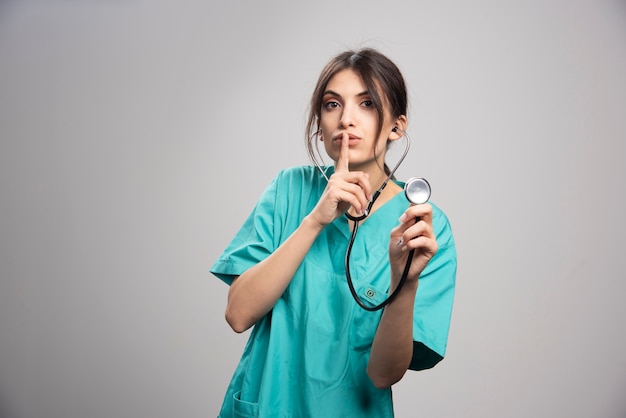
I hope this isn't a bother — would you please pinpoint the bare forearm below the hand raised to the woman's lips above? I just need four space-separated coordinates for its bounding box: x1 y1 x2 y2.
226 216 323 332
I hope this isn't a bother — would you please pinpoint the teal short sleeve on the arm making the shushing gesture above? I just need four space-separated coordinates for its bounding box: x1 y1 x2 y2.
210 175 281 285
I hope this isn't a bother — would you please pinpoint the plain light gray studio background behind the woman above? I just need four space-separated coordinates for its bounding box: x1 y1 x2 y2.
0 0 626 418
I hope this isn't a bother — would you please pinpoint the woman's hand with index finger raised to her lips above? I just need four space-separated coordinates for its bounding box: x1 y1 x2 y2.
310 132 372 227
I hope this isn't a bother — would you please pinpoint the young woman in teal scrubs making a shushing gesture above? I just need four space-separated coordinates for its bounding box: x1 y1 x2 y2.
211 48 456 418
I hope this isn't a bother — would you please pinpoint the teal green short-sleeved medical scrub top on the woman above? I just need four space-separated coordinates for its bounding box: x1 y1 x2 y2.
210 166 456 418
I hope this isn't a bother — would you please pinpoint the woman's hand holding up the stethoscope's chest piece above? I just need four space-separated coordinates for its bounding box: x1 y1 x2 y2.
389 203 438 289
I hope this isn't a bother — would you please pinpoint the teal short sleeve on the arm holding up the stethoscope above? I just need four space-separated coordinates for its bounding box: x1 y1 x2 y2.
409 207 457 370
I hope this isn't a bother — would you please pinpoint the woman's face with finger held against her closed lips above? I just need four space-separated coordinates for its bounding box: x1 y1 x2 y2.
320 69 402 171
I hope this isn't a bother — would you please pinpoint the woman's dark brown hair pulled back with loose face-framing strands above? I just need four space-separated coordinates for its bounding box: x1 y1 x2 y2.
305 48 408 174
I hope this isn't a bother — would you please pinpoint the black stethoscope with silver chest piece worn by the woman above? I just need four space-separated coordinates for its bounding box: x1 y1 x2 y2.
345 128 430 312
